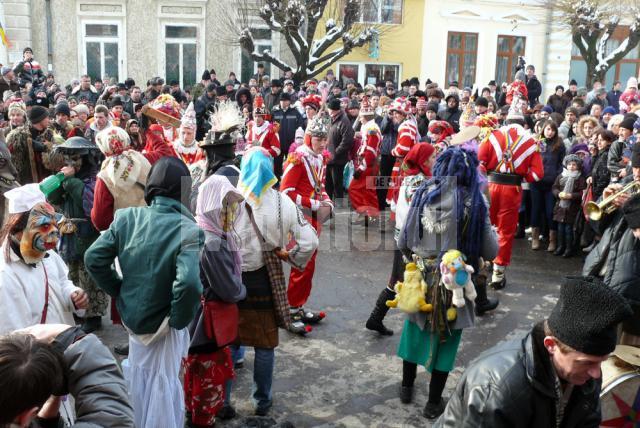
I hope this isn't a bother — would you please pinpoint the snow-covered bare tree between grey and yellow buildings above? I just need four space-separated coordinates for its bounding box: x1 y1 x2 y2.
225 0 381 81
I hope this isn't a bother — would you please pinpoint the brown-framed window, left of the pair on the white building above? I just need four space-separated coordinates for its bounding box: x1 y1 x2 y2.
444 31 478 87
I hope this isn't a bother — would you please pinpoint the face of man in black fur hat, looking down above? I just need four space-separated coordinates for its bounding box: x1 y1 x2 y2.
544 336 608 386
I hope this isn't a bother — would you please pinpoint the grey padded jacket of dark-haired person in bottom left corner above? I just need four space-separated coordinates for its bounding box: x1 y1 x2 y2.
54 329 134 428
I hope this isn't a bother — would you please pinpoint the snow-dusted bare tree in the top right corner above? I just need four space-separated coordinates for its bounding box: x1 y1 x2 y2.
546 0 640 87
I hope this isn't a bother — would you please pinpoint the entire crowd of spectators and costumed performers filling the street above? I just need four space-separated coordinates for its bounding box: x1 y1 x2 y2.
0 48 640 427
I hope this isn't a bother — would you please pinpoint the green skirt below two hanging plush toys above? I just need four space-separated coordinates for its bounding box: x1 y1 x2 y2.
398 320 462 372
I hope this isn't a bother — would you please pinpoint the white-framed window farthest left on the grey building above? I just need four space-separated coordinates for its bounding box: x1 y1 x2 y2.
82 23 121 80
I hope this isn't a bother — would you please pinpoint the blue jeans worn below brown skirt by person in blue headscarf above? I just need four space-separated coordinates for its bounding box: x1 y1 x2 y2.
224 346 276 409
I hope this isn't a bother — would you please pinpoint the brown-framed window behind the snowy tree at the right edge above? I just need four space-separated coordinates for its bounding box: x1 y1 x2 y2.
569 26 640 87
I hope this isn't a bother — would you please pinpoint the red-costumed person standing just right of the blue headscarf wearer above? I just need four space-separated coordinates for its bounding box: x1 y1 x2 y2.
280 115 333 334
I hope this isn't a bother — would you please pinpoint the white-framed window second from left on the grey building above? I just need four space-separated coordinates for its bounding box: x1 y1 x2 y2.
164 25 198 88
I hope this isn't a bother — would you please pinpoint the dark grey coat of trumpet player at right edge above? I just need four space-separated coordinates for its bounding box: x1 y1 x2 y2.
582 204 640 314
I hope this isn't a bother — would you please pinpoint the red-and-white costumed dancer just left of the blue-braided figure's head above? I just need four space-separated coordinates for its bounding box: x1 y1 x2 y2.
387 98 420 213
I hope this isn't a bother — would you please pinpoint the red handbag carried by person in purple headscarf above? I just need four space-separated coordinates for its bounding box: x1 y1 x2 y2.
202 298 240 348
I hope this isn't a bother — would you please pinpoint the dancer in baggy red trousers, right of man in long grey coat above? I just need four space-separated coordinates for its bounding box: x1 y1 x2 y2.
349 97 382 226
